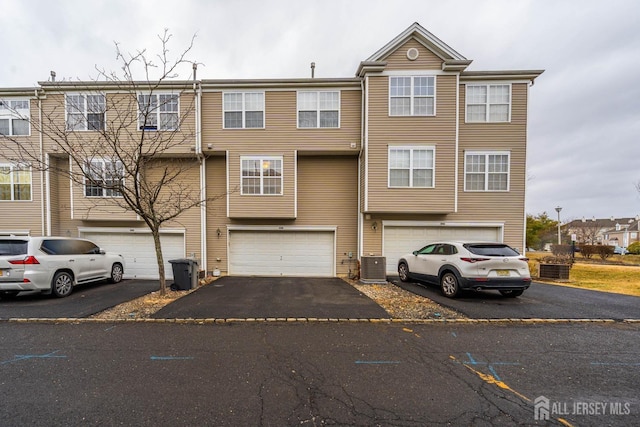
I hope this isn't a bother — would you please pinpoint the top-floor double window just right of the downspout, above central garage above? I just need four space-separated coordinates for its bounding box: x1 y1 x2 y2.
222 92 264 129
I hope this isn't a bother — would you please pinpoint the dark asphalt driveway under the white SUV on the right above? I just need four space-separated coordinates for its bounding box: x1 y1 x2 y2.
388 277 640 320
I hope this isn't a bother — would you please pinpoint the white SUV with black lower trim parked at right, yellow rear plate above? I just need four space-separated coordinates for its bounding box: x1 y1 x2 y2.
398 242 531 298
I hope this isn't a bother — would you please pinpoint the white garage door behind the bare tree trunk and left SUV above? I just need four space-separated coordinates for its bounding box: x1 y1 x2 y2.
82 231 185 279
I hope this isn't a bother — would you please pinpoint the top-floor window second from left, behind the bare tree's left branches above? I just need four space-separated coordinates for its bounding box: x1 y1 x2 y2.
65 94 106 131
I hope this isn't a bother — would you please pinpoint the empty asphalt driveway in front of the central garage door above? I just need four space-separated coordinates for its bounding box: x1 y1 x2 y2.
153 276 389 319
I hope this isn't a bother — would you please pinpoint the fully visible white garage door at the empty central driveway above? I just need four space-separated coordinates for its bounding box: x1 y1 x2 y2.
229 230 335 277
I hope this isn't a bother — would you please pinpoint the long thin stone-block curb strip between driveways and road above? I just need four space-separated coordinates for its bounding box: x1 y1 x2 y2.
0 317 640 325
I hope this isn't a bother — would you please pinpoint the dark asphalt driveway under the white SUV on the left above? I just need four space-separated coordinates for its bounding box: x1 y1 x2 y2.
0 280 160 319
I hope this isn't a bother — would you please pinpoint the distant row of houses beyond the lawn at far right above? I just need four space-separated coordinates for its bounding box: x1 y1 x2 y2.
563 217 640 247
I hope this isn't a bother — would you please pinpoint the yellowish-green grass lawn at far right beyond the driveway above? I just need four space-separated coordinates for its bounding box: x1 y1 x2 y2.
527 252 640 296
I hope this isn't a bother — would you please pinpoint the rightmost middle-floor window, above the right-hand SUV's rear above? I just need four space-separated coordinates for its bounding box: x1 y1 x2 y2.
464 152 510 191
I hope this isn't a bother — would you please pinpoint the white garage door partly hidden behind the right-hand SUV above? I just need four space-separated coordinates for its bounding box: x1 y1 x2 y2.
383 225 502 274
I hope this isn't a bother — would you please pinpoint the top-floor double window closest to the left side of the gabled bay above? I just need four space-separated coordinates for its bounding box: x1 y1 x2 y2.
298 91 340 128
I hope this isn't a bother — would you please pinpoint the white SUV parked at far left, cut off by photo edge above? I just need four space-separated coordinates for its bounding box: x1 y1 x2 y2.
0 236 124 298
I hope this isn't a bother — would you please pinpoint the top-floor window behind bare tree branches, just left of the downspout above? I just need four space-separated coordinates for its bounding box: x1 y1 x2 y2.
138 93 180 130
